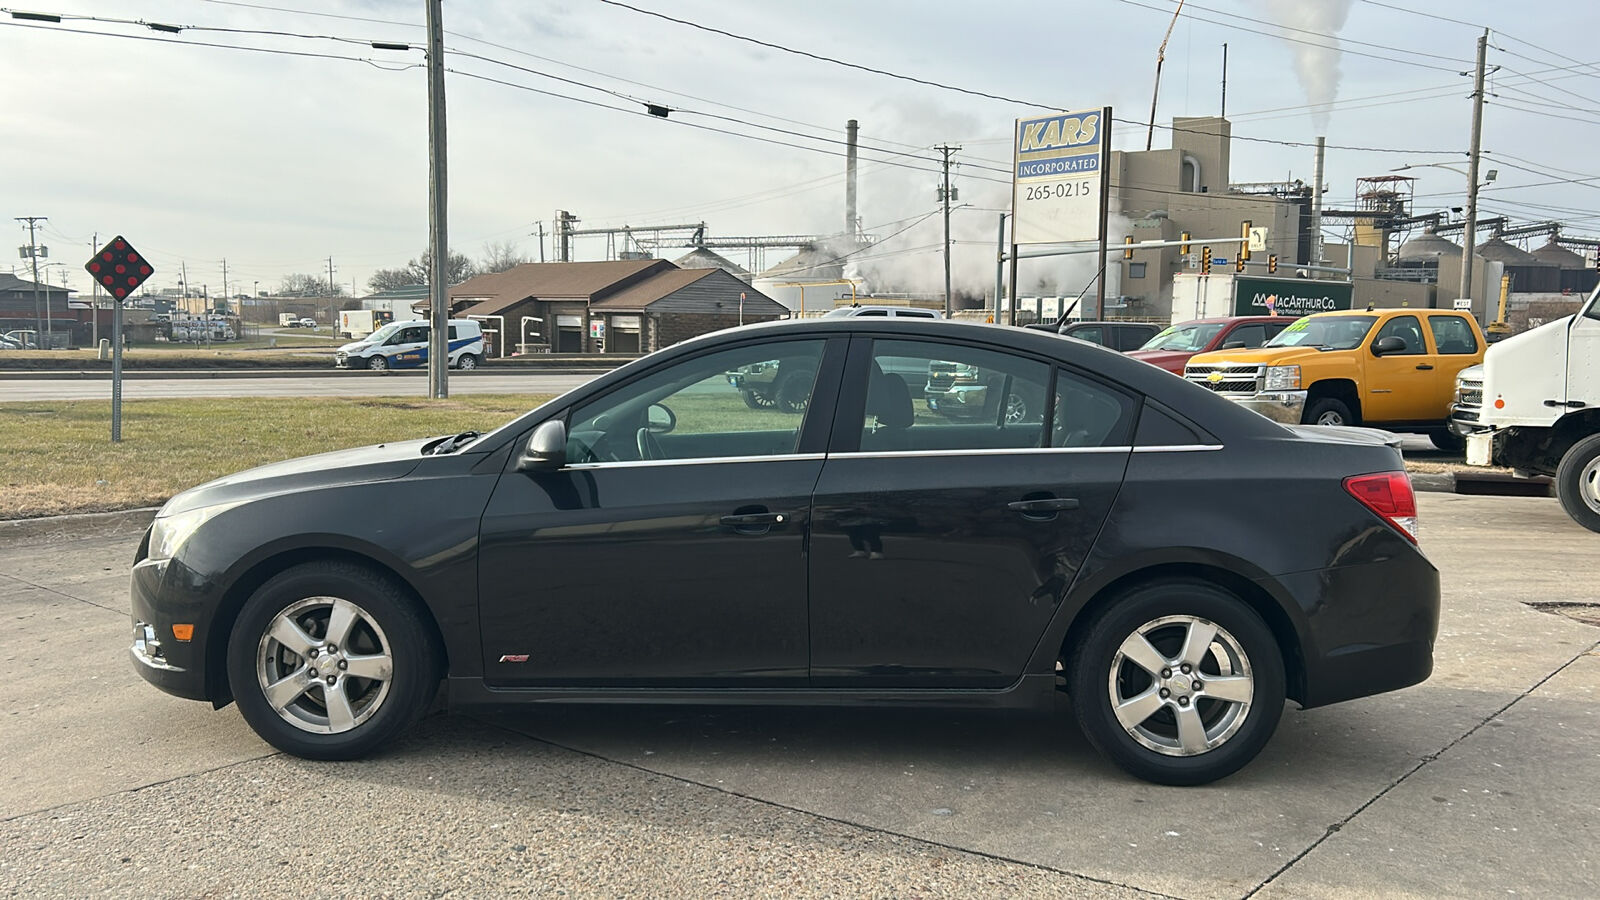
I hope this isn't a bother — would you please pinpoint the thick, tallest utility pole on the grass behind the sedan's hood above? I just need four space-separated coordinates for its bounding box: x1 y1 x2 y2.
427 0 450 400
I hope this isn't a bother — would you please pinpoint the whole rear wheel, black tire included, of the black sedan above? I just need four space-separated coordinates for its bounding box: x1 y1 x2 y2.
1066 578 1285 785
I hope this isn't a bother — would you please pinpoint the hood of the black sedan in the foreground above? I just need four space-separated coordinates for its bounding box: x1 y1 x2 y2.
157 437 438 516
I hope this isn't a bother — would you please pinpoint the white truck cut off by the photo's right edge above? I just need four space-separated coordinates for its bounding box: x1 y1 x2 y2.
1450 283 1600 532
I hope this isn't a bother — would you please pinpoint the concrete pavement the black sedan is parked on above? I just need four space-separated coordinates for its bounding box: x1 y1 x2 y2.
0 493 1600 900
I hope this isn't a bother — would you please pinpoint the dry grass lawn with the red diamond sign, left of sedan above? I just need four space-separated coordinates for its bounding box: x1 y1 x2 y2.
0 394 549 519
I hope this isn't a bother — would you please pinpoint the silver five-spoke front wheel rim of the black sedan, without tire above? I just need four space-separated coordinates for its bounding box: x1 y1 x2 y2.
256 597 394 735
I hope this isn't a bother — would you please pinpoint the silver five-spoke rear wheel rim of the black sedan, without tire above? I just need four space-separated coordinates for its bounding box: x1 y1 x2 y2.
1107 615 1256 756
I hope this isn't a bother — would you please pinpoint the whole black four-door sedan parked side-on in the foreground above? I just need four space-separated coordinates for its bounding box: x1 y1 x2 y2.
131 319 1438 785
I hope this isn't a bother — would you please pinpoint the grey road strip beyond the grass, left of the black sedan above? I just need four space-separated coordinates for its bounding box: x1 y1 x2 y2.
0 372 600 402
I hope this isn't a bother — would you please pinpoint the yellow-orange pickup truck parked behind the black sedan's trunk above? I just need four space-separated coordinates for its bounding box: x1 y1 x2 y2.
1184 309 1486 450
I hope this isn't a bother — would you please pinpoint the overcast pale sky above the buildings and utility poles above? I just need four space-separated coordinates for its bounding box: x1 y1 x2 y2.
0 0 1600 293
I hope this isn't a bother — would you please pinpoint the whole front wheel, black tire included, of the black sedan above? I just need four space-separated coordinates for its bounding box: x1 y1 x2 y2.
227 562 443 759
